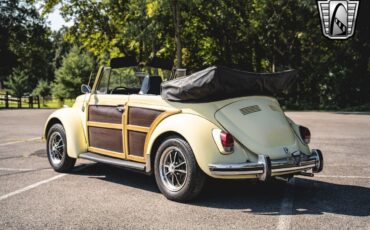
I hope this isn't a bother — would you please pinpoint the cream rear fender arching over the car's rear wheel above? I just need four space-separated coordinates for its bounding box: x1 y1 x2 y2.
145 113 248 177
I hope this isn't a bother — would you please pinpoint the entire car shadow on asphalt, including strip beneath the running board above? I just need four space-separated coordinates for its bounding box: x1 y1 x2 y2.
74 164 370 216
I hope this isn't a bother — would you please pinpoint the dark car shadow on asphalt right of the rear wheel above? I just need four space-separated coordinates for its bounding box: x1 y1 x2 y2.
193 178 370 216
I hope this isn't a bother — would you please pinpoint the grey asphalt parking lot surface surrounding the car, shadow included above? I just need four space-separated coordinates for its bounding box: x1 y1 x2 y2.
0 109 370 230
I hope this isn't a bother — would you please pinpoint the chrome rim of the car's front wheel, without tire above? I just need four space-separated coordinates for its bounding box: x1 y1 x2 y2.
48 132 65 166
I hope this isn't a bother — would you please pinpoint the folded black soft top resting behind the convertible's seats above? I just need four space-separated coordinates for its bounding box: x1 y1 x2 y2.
161 66 297 101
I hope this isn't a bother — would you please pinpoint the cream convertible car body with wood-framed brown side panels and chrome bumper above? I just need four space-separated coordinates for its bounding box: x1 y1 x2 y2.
44 63 322 200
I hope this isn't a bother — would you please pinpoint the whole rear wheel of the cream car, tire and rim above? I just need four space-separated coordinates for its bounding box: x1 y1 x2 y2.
154 136 205 202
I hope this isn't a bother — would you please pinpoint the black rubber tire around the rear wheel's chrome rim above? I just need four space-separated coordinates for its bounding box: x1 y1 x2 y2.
154 136 206 202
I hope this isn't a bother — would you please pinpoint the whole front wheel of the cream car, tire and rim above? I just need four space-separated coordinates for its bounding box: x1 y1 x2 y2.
46 124 76 172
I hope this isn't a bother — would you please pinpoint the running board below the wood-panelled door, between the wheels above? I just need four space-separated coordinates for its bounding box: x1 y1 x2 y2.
78 152 145 171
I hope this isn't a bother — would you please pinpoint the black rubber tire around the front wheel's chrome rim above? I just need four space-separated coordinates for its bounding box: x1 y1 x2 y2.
46 124 76 173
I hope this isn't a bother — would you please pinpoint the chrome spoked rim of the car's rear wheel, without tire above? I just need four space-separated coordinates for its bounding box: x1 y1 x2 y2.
159 146 188 192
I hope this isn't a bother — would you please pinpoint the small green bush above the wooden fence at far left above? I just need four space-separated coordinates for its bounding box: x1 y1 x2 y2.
5 68 28 98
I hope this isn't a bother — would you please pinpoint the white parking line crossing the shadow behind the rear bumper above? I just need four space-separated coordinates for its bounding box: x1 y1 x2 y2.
276 178 295 230
